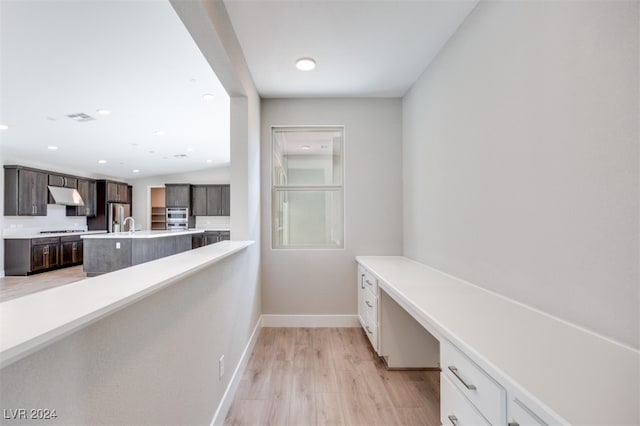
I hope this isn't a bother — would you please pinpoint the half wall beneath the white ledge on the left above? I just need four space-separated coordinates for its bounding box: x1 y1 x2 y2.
0 249 260 425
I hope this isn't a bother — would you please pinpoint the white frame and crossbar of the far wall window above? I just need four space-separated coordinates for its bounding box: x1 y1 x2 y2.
269 125 346 251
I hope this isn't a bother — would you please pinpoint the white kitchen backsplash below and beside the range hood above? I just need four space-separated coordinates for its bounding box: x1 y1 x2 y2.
2 204 87 237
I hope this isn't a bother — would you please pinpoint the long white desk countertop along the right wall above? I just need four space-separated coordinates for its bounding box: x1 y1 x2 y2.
356 256 640 425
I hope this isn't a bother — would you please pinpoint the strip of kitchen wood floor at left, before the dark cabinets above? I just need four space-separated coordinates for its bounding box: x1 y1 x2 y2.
0 265 87 303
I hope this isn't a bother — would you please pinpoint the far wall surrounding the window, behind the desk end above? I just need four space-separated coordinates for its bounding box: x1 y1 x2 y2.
262 99 402 315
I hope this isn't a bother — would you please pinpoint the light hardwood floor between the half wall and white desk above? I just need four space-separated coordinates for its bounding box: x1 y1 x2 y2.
225 328 440 426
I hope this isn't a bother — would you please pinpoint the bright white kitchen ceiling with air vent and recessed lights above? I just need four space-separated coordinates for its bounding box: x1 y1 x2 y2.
0 0 230 180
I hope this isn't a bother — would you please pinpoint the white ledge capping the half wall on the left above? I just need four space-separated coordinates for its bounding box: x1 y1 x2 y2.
0 241 253 368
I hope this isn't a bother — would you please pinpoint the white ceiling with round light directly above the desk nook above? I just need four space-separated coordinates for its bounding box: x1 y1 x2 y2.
224 0 478 97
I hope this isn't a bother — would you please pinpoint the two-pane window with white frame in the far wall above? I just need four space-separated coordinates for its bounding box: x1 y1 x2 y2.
271 127 344 249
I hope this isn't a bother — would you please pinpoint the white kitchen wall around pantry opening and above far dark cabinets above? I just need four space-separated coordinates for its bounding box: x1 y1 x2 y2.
128 166 231 229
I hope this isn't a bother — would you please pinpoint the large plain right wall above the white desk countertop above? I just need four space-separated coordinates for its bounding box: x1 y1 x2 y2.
403 1 640 347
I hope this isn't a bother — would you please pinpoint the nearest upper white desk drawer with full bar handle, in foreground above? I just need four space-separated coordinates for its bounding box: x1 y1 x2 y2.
440 340 507 424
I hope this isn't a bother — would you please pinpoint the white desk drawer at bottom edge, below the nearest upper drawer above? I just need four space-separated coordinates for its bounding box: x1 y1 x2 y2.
440 371 490 426
